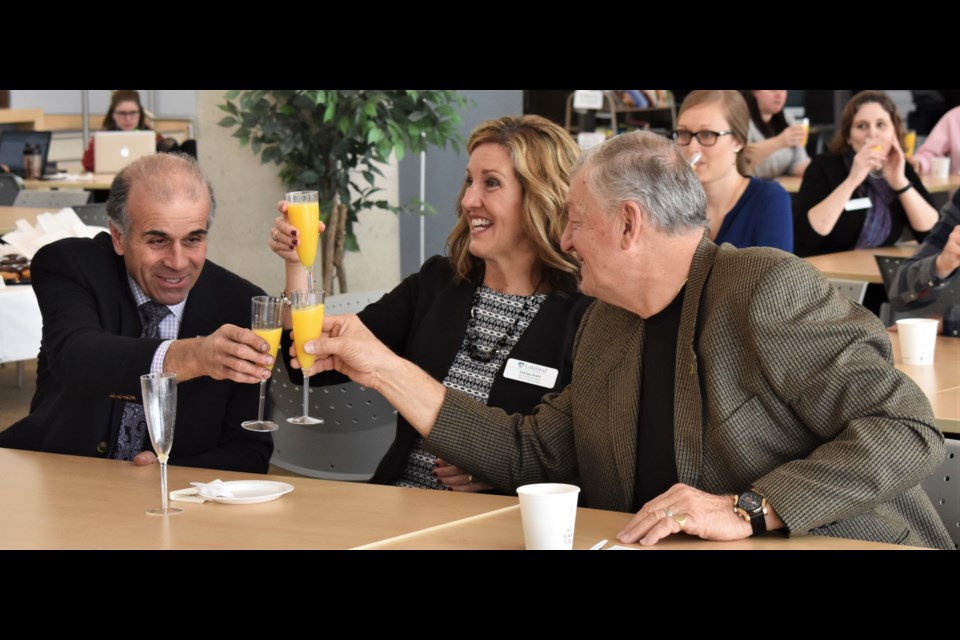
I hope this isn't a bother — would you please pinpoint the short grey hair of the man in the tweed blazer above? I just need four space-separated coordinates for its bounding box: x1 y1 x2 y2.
573 131 709 235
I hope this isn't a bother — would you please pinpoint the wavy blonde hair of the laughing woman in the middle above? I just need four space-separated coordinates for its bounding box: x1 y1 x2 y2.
447 115 580 292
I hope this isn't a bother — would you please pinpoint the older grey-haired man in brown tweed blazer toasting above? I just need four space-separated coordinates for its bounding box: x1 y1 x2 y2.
314 133 950 548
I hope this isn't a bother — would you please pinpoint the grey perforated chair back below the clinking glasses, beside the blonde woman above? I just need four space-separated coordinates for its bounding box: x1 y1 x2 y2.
268 291 397 482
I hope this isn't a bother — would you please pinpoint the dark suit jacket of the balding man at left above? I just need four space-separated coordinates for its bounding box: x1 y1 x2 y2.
0 233 273 473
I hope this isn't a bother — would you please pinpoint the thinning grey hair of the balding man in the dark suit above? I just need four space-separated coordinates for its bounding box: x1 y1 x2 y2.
107 153 217 235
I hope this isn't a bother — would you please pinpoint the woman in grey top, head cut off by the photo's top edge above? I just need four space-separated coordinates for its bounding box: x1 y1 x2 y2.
743 89 810 180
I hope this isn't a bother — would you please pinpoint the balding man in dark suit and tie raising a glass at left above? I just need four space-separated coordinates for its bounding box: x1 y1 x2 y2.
0 154 273 473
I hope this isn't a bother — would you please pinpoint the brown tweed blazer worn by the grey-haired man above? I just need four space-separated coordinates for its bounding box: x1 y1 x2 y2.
427 236 951 548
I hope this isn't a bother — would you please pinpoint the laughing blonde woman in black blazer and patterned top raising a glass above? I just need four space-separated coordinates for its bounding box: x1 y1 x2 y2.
270 116 590 491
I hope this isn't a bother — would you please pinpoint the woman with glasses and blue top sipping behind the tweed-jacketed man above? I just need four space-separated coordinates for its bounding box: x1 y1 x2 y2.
673 90 793 251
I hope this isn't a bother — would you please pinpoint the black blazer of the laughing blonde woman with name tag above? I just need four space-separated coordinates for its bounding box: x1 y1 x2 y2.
281 256 593 484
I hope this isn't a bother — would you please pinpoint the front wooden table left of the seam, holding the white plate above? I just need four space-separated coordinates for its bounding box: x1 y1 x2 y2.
0 443 516 549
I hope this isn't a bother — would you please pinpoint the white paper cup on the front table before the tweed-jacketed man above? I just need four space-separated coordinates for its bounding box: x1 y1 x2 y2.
517 483 580 551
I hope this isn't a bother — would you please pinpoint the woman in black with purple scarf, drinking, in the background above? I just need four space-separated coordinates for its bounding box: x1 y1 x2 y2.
794 91 939 256
